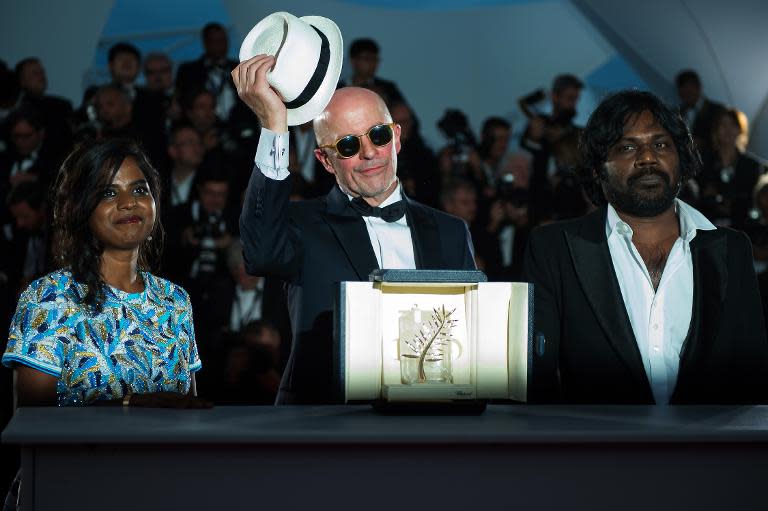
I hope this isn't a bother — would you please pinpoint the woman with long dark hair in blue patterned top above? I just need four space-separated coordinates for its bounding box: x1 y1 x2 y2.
2 139 210 407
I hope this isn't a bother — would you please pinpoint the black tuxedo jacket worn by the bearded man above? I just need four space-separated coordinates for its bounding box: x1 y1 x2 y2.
524 207 768 404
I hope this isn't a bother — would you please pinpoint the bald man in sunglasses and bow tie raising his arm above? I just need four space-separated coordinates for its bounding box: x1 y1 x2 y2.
232 55 475 404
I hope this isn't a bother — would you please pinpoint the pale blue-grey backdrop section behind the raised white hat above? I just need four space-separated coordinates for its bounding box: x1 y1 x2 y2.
224 0 614 146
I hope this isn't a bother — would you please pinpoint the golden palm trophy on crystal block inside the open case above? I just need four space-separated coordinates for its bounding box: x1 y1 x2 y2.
398 304 461 384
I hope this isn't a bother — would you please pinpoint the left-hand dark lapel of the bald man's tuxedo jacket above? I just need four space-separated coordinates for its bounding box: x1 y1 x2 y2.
324 186 379 281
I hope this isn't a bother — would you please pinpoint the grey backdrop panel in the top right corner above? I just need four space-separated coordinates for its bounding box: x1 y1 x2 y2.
574 0 768 157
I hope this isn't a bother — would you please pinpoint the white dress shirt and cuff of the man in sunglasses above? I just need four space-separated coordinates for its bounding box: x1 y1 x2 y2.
255 128 416 269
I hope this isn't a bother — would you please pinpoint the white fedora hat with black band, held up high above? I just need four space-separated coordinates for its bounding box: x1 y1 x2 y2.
240 12 344 126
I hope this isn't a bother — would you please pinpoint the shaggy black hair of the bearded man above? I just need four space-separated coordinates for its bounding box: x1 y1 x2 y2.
578 90 701 206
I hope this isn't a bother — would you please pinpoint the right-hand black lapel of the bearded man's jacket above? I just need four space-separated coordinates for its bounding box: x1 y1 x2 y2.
680 230 728 373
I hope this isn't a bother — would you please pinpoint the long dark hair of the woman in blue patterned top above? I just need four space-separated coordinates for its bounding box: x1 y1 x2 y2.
52 139 164 310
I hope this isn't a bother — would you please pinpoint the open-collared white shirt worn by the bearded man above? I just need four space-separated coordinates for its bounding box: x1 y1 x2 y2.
605 199 715 404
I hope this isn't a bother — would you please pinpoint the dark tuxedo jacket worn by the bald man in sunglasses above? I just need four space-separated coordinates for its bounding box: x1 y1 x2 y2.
240 168 475 404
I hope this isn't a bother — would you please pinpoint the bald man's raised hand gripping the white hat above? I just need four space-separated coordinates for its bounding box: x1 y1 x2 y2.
232 55 288 133
